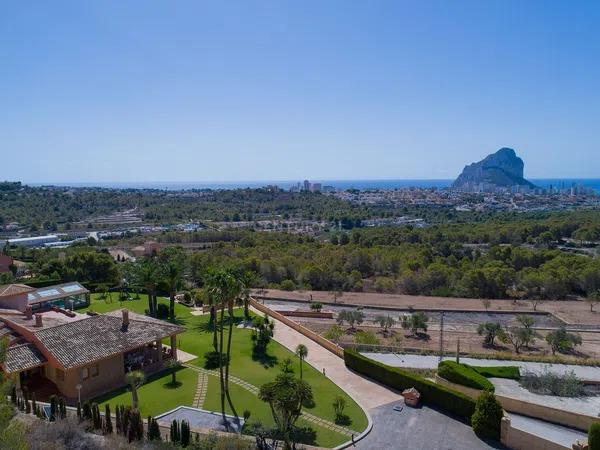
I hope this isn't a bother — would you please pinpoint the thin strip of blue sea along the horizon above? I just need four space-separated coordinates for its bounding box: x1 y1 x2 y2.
27 178 600 194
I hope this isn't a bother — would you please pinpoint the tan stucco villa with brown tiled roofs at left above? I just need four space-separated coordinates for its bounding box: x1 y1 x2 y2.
0 283 185 403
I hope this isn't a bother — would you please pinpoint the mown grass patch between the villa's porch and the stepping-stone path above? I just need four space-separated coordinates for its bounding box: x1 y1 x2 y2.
95 368 198 417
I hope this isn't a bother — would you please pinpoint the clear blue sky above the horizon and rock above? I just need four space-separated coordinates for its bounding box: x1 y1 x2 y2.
0 0 600 182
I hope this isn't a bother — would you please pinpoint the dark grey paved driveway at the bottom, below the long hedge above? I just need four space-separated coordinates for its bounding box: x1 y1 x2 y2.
350 402 504 450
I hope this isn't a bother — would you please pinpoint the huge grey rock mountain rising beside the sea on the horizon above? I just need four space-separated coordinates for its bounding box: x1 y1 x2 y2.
452 147 535 189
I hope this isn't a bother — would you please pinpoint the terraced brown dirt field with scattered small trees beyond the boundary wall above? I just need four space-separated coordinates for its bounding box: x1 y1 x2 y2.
254 290 600 359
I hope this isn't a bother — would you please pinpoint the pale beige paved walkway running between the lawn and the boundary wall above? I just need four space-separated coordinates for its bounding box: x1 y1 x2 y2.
252 308 402 410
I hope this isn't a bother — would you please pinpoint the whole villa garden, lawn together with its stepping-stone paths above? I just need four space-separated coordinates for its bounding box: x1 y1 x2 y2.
88 294 367 447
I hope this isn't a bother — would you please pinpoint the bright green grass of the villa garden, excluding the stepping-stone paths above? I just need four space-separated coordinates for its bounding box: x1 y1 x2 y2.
84 294 367 447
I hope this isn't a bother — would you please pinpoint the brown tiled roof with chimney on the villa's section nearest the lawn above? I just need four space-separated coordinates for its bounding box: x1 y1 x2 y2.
35 312 185 369
